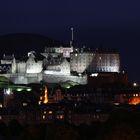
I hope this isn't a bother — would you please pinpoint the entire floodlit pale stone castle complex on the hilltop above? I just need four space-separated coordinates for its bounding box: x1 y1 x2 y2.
0 46 120 84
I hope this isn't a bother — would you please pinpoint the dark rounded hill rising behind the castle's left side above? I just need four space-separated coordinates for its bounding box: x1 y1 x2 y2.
0 33 62 55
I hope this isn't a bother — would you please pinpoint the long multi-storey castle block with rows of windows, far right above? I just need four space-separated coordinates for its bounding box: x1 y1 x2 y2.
70 52 120 73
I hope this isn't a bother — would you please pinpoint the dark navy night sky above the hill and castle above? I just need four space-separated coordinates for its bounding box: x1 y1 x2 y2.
0 0 140 82
